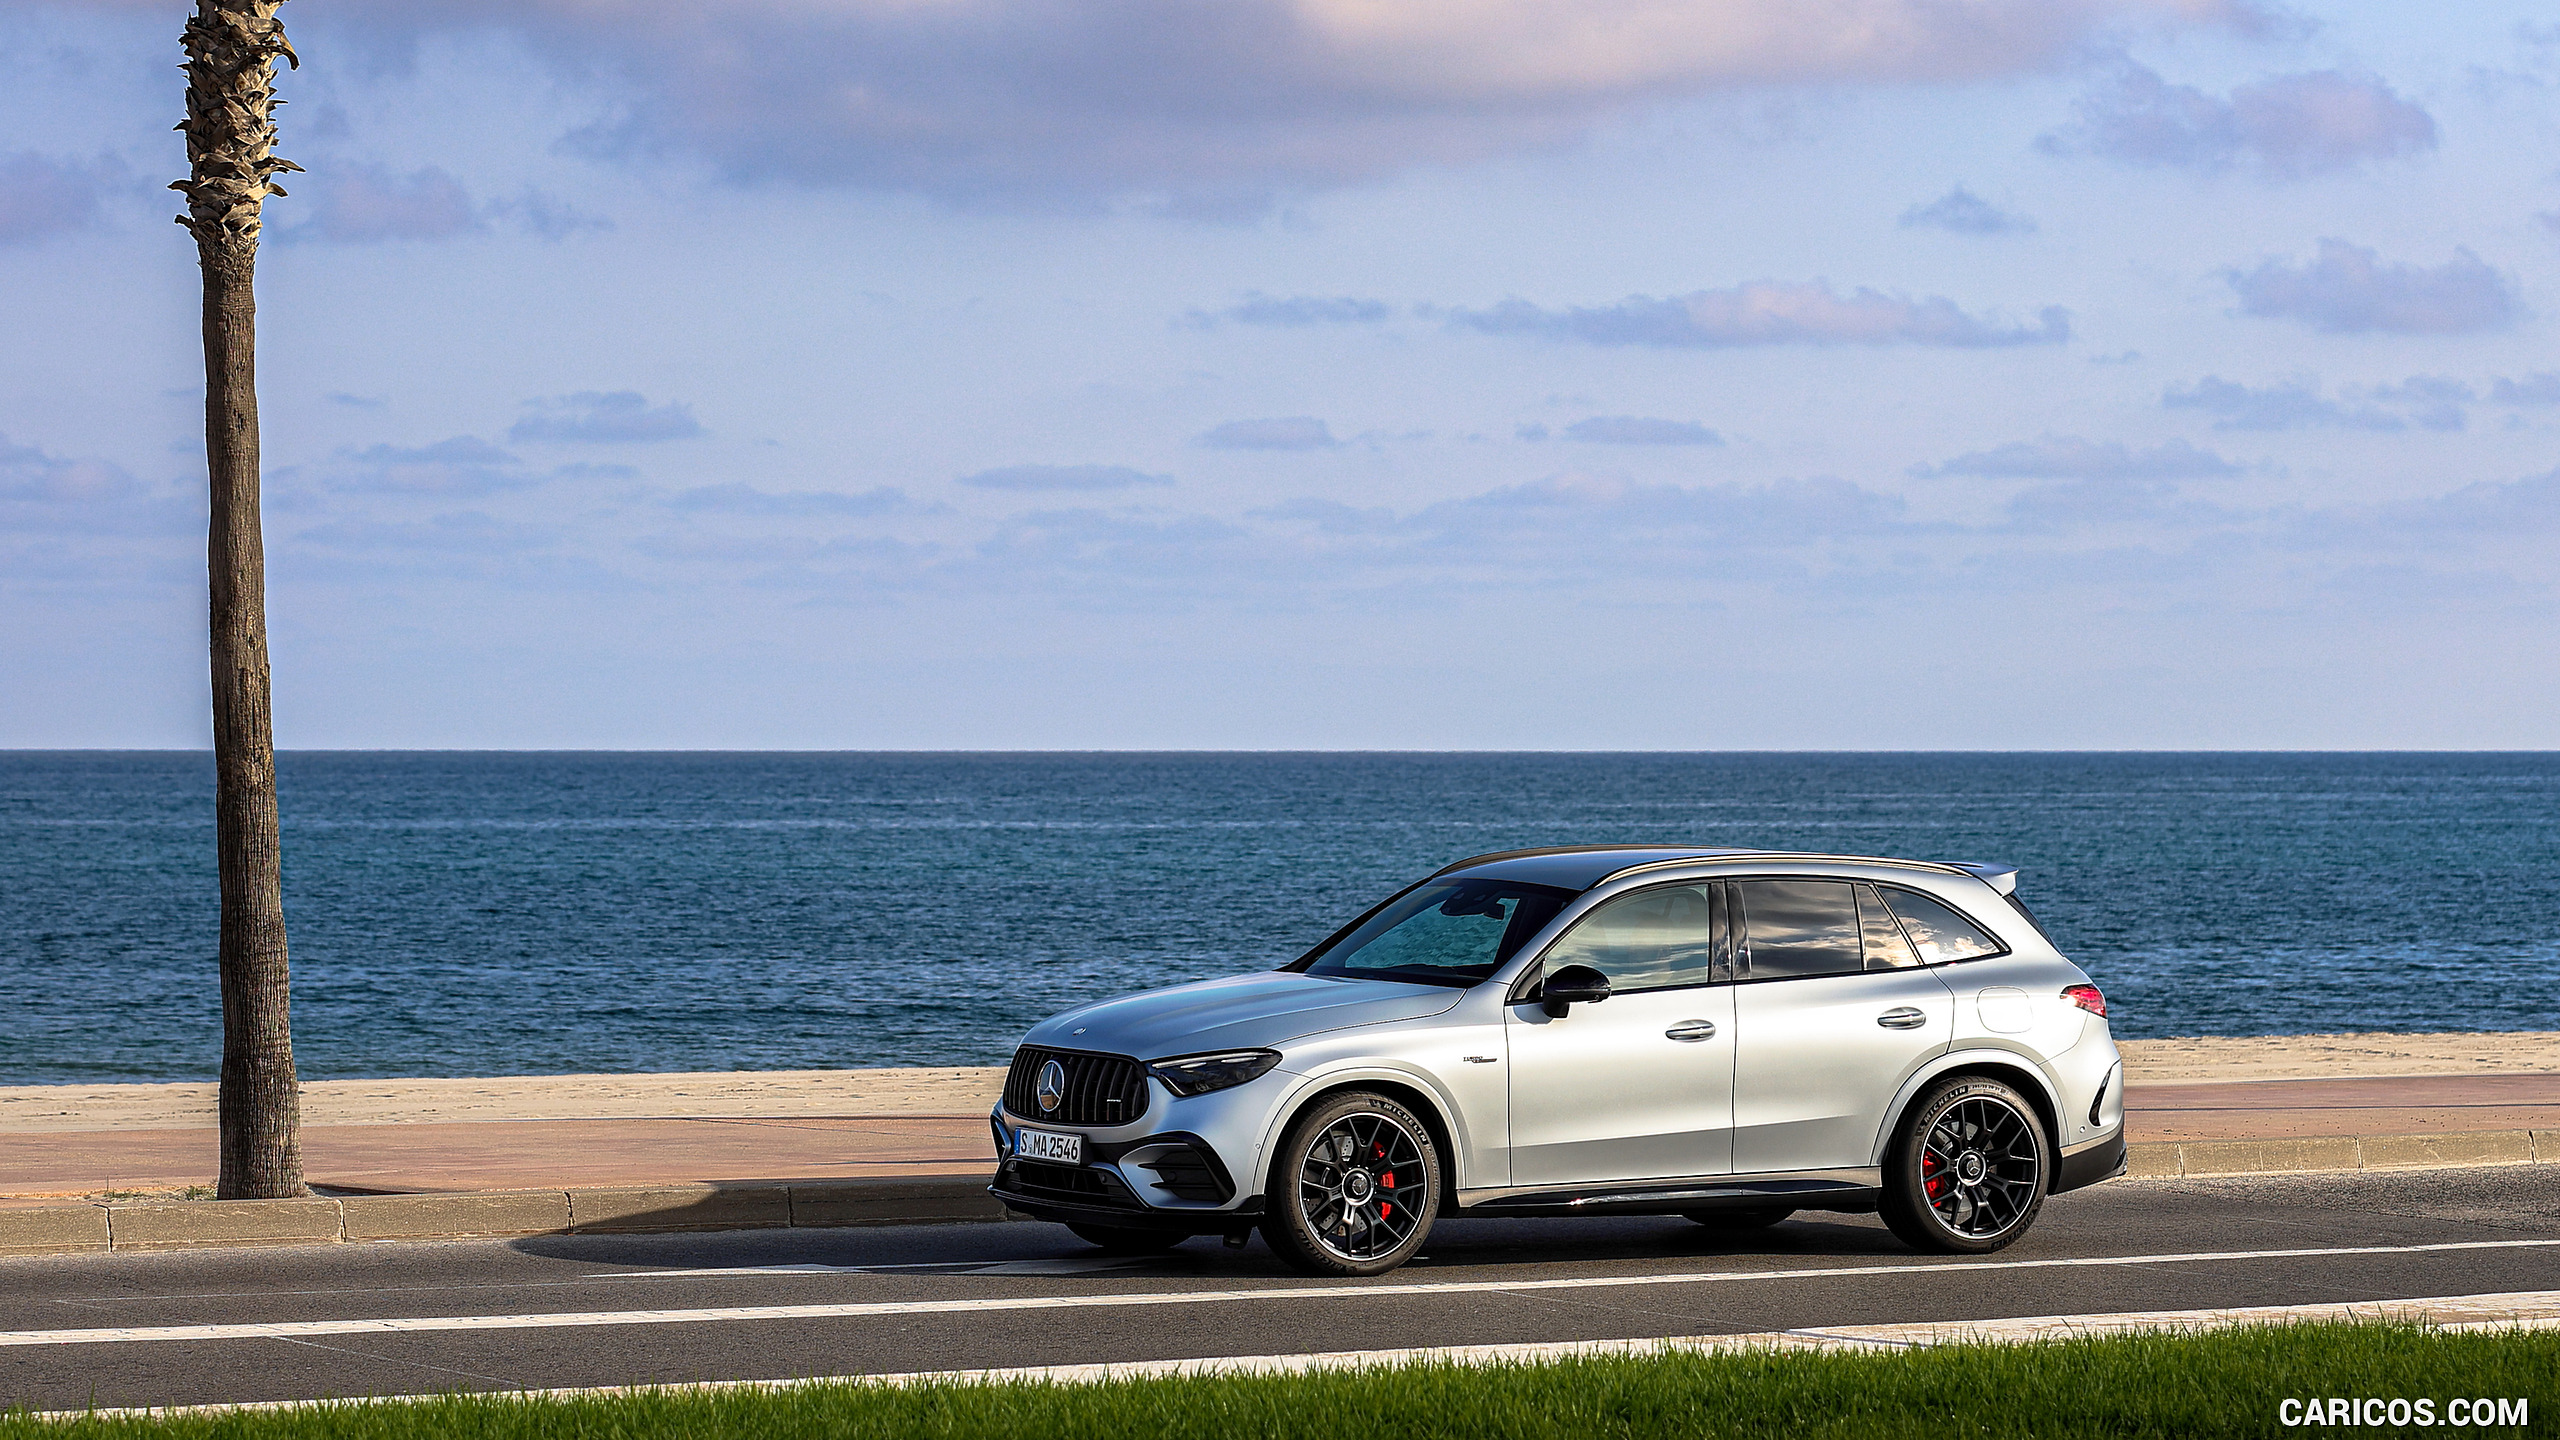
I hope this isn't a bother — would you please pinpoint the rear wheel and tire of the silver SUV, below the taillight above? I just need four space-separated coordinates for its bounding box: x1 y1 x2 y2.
1876 1076 2053 1256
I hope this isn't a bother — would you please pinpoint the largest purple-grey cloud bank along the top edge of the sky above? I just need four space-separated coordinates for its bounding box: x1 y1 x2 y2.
189 0 2263 215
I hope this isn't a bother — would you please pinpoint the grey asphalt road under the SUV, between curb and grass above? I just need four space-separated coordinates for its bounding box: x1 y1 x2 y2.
0 1166 2560 1409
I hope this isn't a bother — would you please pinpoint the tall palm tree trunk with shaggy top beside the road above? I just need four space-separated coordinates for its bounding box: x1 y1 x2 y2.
172 0 302 1199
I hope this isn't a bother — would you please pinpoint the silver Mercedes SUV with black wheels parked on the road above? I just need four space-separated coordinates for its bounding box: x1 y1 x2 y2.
991 846 2125 1276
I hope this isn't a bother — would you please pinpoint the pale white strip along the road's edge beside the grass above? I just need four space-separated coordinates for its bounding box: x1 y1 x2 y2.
36 1289 2560 1420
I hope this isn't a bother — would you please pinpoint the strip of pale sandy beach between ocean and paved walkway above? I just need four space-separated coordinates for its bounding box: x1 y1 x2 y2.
0 1030 2560 1135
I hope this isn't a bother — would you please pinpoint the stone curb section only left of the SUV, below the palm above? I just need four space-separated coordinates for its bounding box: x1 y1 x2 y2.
0 1176 1006 1256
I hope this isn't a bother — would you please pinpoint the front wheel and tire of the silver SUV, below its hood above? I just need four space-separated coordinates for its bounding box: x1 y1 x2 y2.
1262 1089 1444 1276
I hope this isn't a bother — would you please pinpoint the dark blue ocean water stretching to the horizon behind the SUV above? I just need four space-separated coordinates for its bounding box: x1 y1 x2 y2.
0 751 2560 1084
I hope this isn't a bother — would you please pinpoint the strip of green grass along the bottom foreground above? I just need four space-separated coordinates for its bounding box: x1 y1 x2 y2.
0 1325 2560 1440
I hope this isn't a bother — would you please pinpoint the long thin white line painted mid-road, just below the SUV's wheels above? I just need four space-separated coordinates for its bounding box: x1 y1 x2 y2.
0 1240 2560 1348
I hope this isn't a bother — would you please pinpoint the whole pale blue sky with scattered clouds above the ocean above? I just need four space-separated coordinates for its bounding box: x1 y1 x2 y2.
0 0 2560 751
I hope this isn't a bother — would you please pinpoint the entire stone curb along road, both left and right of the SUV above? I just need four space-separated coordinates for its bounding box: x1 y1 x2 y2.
0 1130 2560 1256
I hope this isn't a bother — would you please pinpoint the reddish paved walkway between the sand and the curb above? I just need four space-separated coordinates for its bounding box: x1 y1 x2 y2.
0 1074 2560 1207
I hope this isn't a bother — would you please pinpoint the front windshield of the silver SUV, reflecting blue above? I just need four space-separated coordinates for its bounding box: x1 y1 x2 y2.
1295 879 1574 986
